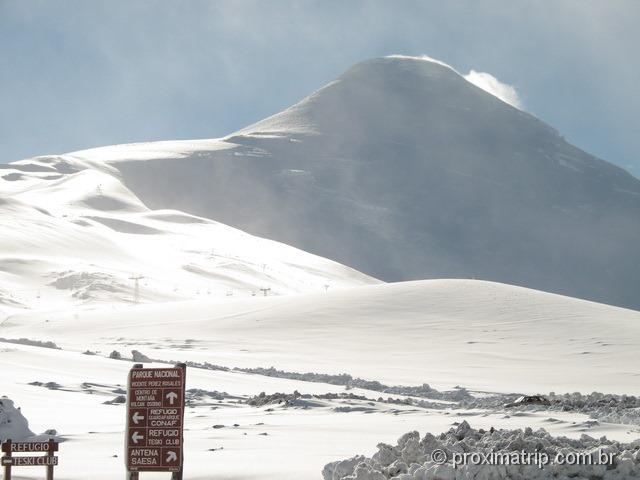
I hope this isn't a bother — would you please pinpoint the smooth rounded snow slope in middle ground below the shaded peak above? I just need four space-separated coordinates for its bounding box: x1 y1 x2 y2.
5 280 640 395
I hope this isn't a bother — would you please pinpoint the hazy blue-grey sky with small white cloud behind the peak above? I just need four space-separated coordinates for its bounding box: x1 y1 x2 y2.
0 0 640 177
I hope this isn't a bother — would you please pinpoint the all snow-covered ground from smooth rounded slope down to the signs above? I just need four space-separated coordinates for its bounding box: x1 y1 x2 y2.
0 280 640 480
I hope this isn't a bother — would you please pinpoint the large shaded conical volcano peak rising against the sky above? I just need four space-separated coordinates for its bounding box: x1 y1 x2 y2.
55 57 640 308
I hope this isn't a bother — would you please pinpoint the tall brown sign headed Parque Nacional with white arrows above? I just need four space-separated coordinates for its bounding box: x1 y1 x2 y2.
126 367 185 472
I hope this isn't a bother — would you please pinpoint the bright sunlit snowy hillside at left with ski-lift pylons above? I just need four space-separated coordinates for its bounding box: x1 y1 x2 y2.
0 152 376 317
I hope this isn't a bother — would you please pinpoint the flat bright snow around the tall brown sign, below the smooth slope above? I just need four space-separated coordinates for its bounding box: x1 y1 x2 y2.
0 344 640 480
